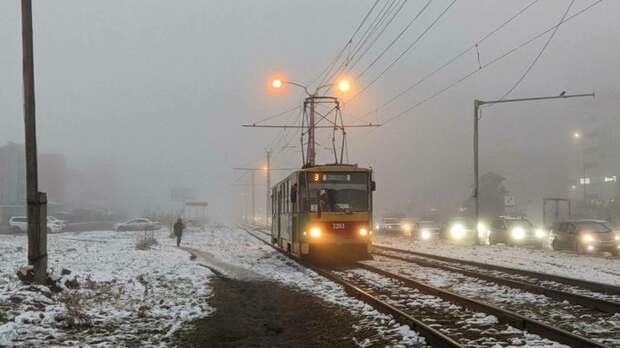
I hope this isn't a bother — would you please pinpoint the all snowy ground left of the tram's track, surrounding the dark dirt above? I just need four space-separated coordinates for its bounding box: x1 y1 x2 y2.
0 225 424 347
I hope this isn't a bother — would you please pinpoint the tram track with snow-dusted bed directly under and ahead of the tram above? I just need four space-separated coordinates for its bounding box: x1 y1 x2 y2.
244 228 607 347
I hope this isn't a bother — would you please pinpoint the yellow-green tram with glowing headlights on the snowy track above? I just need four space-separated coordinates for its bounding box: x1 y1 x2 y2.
271 164 375 260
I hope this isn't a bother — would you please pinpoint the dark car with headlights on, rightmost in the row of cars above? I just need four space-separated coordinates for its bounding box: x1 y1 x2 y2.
551 219 620 256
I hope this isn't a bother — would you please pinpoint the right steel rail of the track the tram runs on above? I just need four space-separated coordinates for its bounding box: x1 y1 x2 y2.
355 263 607 348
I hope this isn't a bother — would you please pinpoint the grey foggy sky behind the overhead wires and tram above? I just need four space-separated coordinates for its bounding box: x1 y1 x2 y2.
0 0 620 219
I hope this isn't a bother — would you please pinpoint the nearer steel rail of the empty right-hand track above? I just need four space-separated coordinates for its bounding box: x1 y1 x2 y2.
373 251 620 314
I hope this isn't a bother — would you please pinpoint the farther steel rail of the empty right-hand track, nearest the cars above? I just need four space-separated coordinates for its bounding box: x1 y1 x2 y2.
372 244 620 295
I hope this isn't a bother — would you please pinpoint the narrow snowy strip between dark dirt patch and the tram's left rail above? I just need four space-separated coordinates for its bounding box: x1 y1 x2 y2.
178 226 423 347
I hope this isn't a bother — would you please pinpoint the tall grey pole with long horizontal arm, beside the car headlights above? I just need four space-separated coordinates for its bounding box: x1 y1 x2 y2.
473 92 594 244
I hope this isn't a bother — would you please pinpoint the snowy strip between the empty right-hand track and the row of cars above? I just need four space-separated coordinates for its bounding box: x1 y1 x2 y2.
373 235 620 286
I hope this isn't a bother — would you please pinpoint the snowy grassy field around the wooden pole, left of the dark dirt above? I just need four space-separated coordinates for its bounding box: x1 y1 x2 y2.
0 230 212 347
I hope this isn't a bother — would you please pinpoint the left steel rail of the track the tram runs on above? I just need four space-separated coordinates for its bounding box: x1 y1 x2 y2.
240 226 464 348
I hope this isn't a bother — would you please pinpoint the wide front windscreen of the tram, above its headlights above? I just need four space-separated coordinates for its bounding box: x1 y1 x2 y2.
308 173 368 213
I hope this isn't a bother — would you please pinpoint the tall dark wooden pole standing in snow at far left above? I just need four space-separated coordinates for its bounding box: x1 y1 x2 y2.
22 0 47 284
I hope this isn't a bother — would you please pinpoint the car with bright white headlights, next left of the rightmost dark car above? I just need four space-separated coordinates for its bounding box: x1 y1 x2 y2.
489 216 548 248
